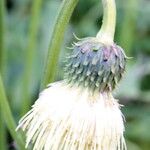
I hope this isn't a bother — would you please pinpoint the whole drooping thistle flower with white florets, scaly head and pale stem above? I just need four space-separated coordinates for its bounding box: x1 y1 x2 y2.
17 0 127 150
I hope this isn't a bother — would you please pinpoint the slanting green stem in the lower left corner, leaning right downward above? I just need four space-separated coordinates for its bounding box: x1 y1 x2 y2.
0 75 25 150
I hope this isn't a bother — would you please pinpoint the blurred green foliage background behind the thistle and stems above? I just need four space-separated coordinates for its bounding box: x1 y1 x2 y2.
0 0 150 150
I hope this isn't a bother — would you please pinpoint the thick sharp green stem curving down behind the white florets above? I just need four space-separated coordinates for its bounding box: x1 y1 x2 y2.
41 0 78 88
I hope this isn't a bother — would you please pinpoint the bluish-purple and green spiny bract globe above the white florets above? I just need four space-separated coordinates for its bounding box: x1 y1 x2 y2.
65 38 127 92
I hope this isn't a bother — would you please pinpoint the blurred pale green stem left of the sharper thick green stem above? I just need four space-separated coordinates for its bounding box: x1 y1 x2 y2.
21 0 42 115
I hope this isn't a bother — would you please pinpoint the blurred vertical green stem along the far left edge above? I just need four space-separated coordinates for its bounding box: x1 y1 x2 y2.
0 0 7 150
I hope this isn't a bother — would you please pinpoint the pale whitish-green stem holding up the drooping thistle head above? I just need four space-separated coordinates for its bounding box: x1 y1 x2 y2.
97 0 116 44
